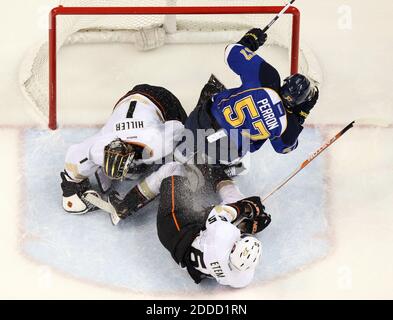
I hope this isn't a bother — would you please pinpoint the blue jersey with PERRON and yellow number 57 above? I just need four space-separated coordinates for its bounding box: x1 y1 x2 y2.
211 44 298 154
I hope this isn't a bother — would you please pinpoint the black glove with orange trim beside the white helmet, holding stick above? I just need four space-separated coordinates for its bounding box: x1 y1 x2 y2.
230 197 271 234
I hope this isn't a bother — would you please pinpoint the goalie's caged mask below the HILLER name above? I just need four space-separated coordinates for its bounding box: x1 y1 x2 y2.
103 139 135 180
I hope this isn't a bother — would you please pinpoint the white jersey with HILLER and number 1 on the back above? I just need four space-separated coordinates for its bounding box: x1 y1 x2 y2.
65 94 184 181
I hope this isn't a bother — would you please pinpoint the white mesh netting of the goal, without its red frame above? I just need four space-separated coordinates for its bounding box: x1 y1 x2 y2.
20 0 321 127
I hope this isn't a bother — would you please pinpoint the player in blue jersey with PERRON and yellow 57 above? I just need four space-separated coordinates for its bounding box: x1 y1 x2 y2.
185 28 319 168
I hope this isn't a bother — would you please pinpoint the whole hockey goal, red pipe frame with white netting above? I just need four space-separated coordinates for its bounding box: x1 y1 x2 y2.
20 0 320 129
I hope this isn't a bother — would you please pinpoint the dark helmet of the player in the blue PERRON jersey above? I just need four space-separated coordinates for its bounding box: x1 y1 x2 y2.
281 73 313 108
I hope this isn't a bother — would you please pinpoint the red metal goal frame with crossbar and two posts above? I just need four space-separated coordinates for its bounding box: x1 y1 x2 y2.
48 6 300 130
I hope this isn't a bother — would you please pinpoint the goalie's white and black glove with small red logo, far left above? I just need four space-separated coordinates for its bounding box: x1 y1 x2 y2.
60 172 100 214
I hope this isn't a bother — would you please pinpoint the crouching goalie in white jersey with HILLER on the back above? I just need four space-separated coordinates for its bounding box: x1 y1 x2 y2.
61 85 187 218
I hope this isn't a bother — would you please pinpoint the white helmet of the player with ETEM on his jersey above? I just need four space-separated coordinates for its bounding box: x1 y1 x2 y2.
229 235 262 271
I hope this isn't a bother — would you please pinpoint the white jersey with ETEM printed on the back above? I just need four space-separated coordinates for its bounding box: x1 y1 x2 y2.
190 206 255 288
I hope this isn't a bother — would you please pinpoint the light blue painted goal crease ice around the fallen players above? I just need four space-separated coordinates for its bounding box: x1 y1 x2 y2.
23 129 330 294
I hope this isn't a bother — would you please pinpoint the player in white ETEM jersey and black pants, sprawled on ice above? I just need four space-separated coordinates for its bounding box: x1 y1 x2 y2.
157 164 271 288
